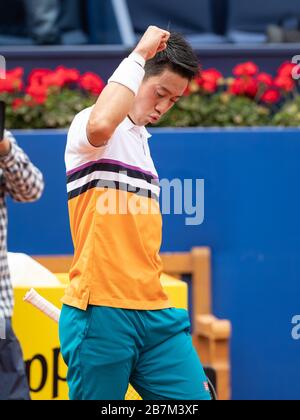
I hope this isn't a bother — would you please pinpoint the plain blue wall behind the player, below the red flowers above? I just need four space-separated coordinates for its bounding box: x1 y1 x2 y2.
9 128 300 399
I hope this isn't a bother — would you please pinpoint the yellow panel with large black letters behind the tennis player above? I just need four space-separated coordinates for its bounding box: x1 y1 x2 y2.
13 274 188 400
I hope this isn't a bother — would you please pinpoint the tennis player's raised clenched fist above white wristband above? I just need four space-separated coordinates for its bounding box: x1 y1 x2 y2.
134 26 171 61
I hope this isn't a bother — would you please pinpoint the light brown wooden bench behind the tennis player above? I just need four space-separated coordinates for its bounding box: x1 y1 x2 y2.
34 247 231 400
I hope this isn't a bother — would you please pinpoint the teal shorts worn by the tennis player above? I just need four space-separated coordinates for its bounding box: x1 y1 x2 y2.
59 305 211 400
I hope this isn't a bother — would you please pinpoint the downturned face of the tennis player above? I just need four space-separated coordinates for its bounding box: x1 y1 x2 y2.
129 70 189 126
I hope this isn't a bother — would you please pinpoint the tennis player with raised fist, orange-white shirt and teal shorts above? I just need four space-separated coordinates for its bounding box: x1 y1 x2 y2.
60 26 210 400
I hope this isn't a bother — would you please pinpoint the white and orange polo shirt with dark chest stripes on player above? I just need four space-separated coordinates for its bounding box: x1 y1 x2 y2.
63 108 171 310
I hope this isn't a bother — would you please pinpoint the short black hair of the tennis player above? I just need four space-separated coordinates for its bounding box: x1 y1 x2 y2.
145 32 199 81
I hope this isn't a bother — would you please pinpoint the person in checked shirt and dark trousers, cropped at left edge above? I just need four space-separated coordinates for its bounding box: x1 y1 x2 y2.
0 131 44 400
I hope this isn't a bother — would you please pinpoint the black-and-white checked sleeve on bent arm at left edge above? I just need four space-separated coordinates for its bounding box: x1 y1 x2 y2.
0 131 44 202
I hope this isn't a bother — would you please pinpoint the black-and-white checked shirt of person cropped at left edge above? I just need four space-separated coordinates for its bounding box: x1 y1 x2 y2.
0 131 44 319
